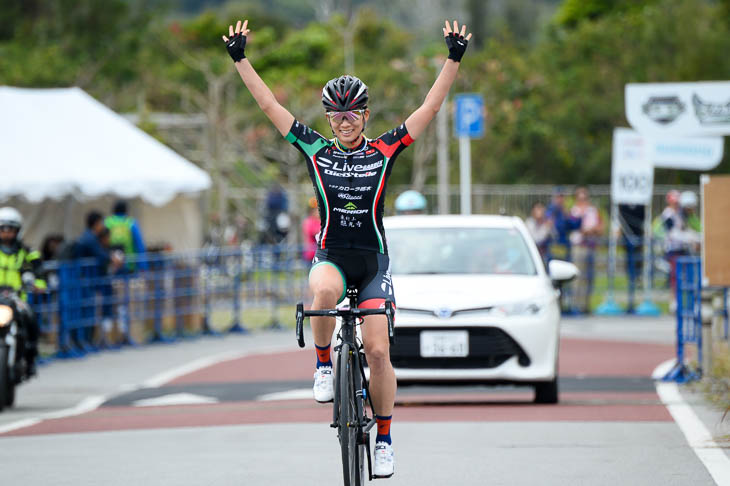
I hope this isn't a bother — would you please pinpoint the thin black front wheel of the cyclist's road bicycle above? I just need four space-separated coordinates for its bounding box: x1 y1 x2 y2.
337 343 362 486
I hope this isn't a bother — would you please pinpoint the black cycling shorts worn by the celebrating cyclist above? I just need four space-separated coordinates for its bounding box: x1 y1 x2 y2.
310 248 395 306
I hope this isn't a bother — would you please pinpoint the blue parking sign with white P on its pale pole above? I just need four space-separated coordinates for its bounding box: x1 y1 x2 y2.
454 94 484 214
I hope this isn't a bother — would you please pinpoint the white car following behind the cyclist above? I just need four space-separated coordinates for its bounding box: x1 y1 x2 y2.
384 216 578 403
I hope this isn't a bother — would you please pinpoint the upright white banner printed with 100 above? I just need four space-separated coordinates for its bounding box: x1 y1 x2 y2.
611 128 654 204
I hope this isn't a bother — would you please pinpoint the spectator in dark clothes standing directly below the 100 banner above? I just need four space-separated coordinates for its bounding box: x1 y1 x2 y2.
618 204 646 313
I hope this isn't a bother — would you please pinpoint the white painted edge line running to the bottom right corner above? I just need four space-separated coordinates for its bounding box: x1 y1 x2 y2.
656 382 730 486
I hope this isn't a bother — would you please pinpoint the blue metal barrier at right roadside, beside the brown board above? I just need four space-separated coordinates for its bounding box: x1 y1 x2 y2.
664 257 728 383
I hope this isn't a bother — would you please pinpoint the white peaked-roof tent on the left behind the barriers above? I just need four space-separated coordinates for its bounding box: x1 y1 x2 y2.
0 86 211 249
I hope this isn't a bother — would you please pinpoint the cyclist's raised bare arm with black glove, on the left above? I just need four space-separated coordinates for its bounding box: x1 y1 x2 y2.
223 20 294 137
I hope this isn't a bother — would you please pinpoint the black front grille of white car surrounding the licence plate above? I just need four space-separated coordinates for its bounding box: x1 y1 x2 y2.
390 327 530 369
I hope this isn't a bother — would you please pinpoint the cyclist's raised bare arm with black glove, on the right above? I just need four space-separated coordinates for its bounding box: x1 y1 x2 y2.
406 20 471 140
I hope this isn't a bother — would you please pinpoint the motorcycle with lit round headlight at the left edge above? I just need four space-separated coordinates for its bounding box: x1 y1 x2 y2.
0 273 35 412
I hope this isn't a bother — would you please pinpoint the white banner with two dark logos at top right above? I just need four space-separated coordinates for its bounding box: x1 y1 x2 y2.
625 81 730 137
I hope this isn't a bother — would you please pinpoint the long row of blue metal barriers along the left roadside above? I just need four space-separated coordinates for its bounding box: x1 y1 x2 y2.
30 246 309 358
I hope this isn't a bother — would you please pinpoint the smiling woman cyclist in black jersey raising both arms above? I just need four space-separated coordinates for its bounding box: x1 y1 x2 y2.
223 20 471 477
